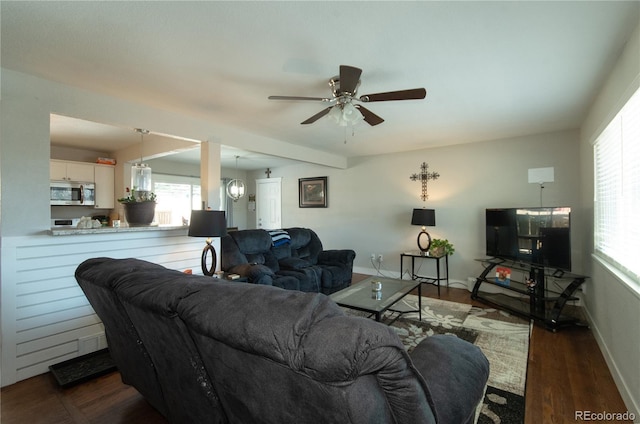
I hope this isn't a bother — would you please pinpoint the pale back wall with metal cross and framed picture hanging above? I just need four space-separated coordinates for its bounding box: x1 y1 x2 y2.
248 131 582 287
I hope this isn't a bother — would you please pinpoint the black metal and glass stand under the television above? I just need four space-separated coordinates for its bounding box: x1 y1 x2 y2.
471 258 588 331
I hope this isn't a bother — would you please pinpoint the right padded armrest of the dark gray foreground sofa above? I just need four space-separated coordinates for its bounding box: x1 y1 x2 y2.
410 335 489 424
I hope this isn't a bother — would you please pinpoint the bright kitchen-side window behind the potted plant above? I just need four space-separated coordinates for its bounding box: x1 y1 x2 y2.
153 174 202 225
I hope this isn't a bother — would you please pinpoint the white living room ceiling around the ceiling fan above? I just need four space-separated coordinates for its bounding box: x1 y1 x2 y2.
0 1 640 171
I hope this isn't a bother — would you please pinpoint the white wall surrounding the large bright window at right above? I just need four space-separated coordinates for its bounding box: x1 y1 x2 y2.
580 21 640 417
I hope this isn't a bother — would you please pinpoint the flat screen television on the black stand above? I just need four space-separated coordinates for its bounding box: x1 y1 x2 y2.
485 207 571 271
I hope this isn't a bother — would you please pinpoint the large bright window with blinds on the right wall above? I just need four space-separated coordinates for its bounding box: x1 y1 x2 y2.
594 85 640 284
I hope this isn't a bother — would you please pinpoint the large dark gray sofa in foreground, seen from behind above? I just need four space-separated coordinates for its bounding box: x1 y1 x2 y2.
76 258 489 424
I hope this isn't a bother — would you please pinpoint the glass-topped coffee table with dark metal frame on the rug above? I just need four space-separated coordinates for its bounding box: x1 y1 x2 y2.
329 277 422 321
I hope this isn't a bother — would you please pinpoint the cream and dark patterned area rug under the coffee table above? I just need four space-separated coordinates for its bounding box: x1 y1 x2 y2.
350 295 531 424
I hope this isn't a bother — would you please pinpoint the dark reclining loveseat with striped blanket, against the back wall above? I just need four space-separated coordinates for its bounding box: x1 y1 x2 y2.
220 227 356 294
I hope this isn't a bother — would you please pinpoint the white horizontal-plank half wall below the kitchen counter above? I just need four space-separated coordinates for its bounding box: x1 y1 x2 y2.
0 229 215 387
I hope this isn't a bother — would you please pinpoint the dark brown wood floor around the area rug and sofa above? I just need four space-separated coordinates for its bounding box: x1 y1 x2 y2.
0 276 627 424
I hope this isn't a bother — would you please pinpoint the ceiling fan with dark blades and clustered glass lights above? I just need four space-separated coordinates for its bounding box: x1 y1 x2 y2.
269 65 427 126
